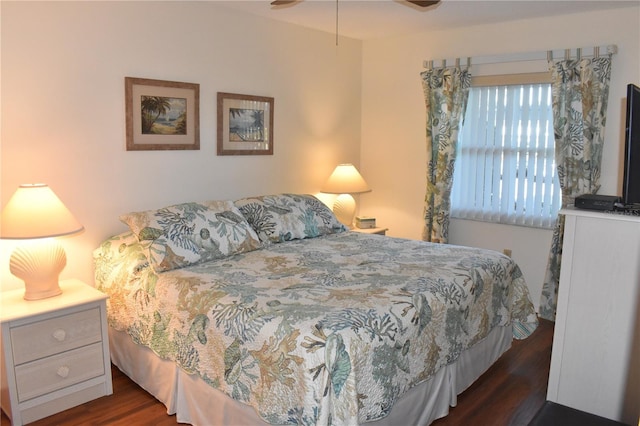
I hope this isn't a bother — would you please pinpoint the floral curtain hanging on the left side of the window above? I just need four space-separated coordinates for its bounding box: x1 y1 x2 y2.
420 66 471 243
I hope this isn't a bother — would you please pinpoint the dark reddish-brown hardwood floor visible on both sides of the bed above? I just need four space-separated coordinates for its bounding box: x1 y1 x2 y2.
0 320 553 426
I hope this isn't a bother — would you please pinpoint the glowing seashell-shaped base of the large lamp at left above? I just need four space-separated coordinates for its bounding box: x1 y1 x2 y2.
9 238 67 300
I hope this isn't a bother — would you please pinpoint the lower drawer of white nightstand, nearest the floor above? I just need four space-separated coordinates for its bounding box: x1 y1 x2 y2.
15 342 104 402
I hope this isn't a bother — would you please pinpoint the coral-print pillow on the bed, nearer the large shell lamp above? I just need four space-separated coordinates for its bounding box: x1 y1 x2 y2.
120 201 260 272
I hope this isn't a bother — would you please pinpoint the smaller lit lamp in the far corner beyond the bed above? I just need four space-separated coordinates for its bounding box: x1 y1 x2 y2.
320 164 371 228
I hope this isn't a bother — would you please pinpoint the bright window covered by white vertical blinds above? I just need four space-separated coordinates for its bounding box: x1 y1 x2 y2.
451 78 561 228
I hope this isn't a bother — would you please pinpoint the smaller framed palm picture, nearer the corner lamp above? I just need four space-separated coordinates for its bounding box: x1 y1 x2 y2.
218 92 273 155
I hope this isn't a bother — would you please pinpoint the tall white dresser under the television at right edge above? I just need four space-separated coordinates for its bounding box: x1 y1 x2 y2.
547 209 640 425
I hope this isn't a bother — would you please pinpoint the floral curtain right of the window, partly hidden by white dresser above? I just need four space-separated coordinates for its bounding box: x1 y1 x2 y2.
539 55 611 321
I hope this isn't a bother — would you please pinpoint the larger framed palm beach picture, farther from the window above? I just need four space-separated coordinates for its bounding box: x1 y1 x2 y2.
124 77 200 151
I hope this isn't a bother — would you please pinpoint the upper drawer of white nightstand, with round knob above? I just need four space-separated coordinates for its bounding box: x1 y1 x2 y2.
11 308 102 365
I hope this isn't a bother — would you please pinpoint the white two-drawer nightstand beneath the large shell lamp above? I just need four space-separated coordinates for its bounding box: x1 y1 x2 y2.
0 280 113 425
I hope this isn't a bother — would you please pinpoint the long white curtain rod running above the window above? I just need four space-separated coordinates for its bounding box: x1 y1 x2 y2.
422 44 618 68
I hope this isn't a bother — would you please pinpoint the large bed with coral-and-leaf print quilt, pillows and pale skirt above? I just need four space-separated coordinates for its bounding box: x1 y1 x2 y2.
94 194 537 425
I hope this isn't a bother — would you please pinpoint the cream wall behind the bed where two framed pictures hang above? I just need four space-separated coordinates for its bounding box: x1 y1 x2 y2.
0 1 361 289
